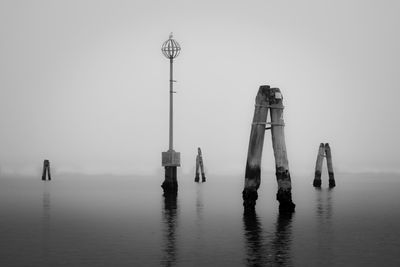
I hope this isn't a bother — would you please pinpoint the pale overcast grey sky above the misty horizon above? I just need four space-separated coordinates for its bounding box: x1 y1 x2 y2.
0 0 400 175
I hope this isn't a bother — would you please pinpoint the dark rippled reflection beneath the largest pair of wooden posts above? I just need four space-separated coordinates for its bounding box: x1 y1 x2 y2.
243 211 293 266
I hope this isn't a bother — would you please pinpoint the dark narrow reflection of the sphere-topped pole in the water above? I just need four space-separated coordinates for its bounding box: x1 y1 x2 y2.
161 194 178 266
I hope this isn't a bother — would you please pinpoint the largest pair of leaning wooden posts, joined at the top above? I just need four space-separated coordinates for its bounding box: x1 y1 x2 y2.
242 85 295 212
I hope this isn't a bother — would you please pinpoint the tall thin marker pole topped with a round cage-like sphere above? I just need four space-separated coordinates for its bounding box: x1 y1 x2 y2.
161 33 181 194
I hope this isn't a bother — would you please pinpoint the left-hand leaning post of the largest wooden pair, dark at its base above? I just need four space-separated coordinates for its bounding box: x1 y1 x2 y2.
242 85 270 209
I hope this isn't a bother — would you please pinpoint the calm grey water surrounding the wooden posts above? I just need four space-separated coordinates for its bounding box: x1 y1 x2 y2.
0 174 400 266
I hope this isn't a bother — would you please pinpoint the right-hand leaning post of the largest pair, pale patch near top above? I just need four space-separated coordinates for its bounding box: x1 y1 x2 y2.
268 88 296 212
